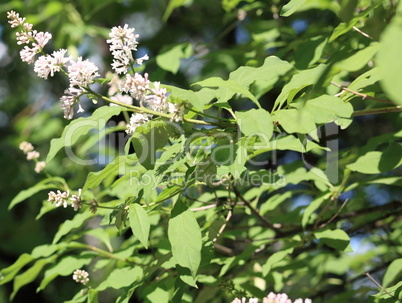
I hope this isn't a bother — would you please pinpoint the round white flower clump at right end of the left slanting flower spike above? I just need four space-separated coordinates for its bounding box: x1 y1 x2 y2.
68 57 99 87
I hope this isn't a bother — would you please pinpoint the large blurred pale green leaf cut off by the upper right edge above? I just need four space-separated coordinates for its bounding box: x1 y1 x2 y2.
376 15 402 105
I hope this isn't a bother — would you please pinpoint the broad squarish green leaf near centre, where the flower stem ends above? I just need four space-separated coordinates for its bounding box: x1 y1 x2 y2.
236 108 274 142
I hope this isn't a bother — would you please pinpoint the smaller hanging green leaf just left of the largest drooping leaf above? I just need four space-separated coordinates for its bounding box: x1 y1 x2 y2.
128 203 151 249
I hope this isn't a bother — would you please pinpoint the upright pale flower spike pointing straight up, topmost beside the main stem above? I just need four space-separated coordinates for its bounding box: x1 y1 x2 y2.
106 24 140 74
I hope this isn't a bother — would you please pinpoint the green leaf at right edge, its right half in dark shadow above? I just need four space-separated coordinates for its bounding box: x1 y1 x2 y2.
347 142 402 174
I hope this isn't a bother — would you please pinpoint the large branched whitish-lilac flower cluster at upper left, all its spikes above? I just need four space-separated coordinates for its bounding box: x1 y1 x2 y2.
7 11 183 134
